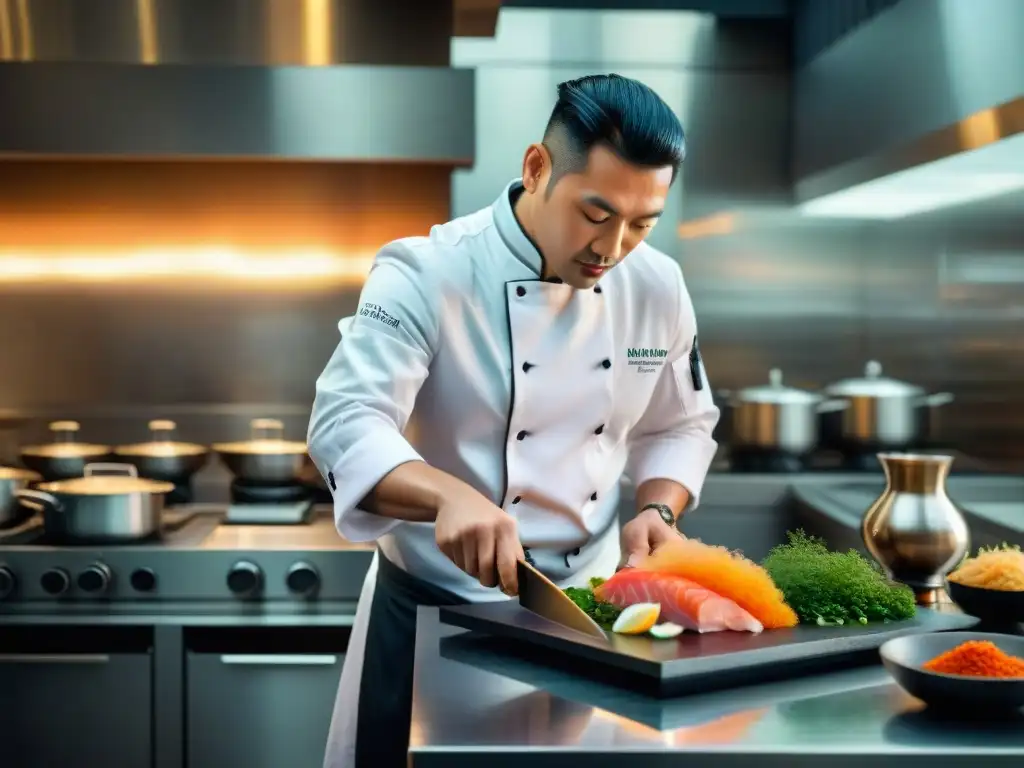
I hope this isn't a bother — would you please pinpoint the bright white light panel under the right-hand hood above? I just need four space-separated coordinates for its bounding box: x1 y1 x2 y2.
798 134 1024 219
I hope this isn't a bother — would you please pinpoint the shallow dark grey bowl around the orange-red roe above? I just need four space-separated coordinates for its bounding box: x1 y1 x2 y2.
879 632 1024 715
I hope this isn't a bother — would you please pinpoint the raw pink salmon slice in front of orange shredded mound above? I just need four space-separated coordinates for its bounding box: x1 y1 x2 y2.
594 568 764 633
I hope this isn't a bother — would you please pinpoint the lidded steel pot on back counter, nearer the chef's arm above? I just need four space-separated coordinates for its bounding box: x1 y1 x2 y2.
721 368 848 457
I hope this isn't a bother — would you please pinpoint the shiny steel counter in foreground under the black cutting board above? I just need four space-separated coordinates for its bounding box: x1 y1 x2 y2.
410 608 1024 768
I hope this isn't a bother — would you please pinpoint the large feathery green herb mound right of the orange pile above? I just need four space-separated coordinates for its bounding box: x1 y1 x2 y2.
762 530 916 627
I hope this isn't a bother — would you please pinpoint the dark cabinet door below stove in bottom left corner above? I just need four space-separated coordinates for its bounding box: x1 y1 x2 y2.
0 651 153 768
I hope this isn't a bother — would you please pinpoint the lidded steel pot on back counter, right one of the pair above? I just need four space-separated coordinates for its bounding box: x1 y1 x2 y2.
821 360 953 452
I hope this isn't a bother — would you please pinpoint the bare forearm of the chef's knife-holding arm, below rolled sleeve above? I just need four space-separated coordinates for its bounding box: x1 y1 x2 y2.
359 461 469 522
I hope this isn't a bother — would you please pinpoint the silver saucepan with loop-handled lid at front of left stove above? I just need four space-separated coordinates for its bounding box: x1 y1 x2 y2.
15 464 174 542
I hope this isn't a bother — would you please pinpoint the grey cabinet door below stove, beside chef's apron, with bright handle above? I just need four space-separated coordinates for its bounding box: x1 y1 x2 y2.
186 630 344 768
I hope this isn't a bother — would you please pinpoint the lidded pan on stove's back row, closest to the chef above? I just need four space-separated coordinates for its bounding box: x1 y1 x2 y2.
213 419 308 485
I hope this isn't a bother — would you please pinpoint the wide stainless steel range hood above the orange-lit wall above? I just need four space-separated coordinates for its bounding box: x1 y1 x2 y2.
0 0 483 166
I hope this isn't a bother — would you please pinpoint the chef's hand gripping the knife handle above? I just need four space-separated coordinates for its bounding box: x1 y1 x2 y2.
434 485 524 595
